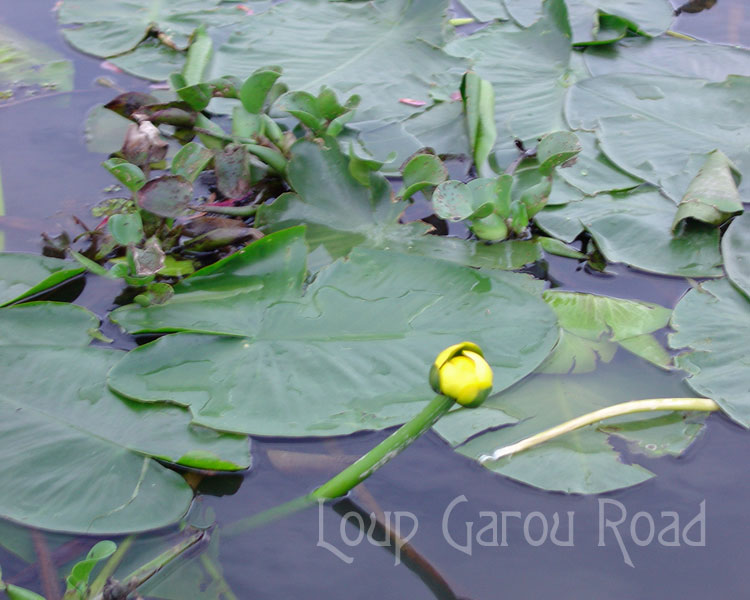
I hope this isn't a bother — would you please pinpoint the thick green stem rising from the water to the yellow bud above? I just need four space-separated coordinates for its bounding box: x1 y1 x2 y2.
224 396 454 536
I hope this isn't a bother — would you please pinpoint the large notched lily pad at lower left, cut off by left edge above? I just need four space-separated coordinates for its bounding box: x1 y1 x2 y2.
0 302 249 534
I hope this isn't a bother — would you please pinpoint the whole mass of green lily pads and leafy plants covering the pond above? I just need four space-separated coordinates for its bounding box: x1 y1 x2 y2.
0 0 750 548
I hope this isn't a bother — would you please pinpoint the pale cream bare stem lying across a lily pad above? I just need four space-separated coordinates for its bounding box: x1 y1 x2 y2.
479 398 719 463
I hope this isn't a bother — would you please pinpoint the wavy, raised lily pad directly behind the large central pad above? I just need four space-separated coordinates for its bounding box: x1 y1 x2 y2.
256 140 541 270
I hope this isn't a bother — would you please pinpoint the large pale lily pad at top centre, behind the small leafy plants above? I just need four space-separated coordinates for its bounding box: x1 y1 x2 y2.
211 0 465 120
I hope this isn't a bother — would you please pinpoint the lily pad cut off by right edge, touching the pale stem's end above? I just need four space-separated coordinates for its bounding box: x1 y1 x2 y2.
669 279 750 427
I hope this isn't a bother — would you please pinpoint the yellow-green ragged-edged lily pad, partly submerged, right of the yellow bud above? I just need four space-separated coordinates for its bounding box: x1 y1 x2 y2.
540 290 672 374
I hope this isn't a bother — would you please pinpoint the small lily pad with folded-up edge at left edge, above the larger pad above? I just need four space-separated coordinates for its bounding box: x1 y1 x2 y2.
0 253 85 306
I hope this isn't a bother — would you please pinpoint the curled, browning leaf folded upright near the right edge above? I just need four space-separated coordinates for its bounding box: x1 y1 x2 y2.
672 150 743 230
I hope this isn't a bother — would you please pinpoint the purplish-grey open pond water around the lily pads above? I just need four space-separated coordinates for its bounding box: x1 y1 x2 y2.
0 0 750 600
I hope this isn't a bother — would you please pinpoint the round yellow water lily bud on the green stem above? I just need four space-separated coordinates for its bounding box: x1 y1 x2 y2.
430 342 492 408
